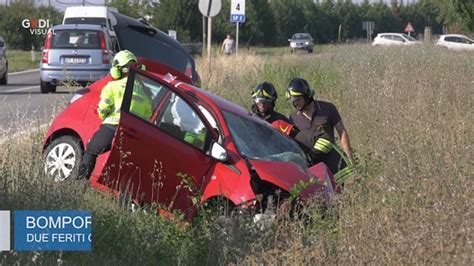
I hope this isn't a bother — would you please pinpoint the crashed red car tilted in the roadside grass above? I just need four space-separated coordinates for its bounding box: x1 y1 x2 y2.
43 58 336 219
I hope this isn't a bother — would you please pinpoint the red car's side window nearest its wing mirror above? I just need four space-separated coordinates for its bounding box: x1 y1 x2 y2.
155 92 207 150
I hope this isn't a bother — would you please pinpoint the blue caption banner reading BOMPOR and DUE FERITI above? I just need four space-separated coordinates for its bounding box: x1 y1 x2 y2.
13 211 92 251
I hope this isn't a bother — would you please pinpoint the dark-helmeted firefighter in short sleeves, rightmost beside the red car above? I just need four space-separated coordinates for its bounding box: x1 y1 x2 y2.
286 78 354 184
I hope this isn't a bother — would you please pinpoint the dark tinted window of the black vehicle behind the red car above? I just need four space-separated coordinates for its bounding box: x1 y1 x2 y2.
116 27 193 78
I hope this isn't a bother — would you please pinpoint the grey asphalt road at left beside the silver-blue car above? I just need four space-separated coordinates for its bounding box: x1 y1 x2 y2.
0 70 76 140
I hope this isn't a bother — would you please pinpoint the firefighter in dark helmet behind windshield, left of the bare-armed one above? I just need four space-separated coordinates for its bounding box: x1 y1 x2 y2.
251 82 290 124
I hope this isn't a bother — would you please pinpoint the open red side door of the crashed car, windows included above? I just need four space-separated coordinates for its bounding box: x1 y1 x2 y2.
98 69 214 215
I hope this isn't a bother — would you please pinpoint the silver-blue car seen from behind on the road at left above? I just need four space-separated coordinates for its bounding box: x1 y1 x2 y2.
40 24 114 93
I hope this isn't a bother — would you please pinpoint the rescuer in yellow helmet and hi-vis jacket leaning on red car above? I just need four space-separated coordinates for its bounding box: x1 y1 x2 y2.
78 50 152 179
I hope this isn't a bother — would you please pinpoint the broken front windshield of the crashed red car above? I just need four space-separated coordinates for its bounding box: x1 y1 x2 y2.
222 111 307 169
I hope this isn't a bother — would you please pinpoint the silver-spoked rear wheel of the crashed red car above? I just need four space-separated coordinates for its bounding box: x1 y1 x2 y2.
43 136 82 182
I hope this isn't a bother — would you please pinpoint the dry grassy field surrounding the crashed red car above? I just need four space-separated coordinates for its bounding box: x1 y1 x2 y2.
0 45 474 265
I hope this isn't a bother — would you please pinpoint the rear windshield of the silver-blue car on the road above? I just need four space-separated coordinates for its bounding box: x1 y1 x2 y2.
51 29 100 49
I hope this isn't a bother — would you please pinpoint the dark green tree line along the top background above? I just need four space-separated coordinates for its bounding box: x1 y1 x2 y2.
0 0 474 50
